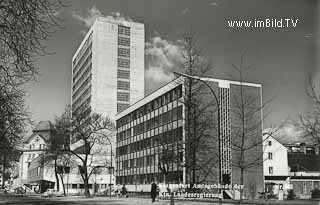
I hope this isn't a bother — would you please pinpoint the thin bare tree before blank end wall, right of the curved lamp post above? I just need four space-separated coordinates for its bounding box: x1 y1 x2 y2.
230 55 281 204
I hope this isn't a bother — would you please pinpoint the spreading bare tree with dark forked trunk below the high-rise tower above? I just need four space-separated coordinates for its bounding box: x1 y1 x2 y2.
60 105 115 196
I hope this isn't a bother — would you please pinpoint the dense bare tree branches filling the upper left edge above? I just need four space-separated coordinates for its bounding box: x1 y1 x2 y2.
0 0 63 187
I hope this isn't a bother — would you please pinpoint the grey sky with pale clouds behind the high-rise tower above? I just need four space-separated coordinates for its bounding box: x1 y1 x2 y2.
27 0 318 135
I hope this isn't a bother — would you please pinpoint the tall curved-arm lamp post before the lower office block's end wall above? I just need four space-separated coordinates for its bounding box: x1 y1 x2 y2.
173 72 221 184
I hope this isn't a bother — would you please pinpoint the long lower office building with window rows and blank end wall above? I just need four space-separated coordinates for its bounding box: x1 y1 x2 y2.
116 77 264 197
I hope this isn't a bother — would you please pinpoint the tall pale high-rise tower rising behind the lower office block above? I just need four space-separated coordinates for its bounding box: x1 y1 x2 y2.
71 17 145 143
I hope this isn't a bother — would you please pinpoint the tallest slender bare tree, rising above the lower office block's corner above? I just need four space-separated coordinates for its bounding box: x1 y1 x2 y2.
181 32 218 184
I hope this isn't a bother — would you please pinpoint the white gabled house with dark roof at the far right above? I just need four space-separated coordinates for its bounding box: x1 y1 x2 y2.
264 131 320 198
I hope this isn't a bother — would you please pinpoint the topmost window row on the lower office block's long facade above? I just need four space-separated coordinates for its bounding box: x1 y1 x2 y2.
117 85 182 128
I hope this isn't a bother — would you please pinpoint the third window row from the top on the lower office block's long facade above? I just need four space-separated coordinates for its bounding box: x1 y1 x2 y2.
116 127 183 156
